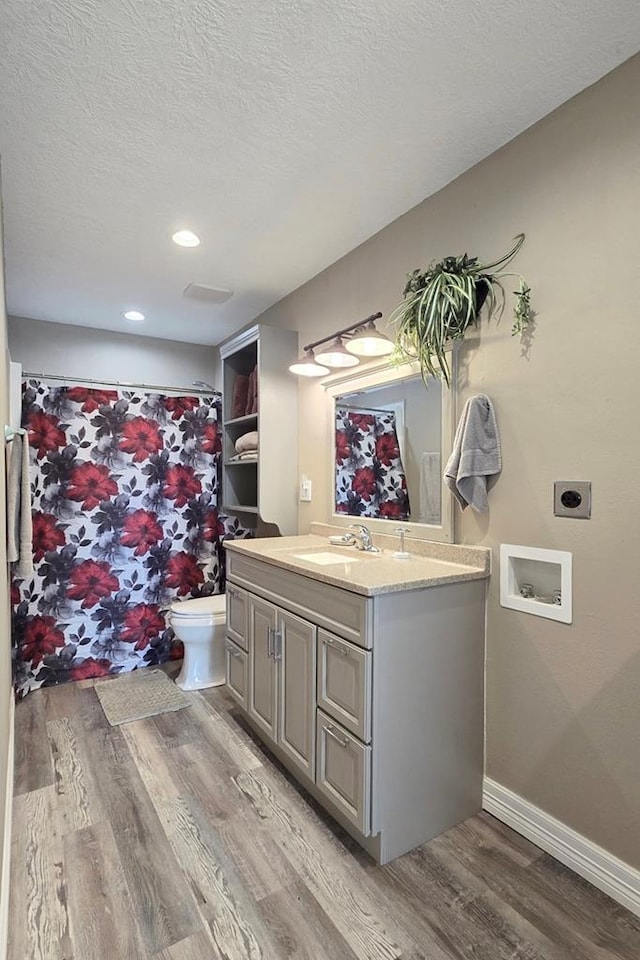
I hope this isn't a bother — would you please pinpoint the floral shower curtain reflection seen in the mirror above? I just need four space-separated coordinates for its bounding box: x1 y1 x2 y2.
336 409 410 520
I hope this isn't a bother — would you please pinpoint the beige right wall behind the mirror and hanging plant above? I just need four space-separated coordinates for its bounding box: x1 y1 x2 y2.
254 56 640 868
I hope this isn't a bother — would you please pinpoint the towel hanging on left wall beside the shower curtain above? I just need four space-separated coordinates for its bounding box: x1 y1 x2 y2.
7 433 34 580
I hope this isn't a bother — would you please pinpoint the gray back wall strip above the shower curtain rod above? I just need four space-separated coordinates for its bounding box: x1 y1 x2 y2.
9 317 220 389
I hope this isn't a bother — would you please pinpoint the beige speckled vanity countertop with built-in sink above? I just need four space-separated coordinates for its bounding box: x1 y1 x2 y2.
224 534 490 597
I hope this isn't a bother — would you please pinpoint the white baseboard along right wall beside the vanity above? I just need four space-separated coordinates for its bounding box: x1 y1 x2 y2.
482 777 640 916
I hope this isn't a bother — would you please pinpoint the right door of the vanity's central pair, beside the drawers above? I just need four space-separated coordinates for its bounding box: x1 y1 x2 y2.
276 611 316 780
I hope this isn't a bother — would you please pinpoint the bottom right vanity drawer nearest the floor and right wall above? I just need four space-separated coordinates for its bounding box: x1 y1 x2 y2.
316 710 371 837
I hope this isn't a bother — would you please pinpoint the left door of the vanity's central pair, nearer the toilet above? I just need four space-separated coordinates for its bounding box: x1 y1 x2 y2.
248 596 278 740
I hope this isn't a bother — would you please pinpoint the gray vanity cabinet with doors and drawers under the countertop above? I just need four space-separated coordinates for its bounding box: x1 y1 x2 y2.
226 541 485 863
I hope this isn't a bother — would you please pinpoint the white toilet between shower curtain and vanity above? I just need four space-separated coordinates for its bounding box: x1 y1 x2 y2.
169 594 226 690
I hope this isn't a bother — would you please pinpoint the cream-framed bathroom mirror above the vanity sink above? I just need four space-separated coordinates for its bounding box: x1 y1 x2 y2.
325 351 456 542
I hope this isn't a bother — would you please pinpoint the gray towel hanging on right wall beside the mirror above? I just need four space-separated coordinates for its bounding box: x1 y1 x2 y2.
444 393 502 513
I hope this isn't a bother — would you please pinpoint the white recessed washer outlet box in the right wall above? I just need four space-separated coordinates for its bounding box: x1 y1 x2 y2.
500 543 573 623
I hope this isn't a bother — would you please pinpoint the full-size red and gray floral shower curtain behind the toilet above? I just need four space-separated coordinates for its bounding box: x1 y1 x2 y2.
12 380 250 696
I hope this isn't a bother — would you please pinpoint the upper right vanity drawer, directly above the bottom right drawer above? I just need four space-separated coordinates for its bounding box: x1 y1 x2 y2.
318 630 371 743
